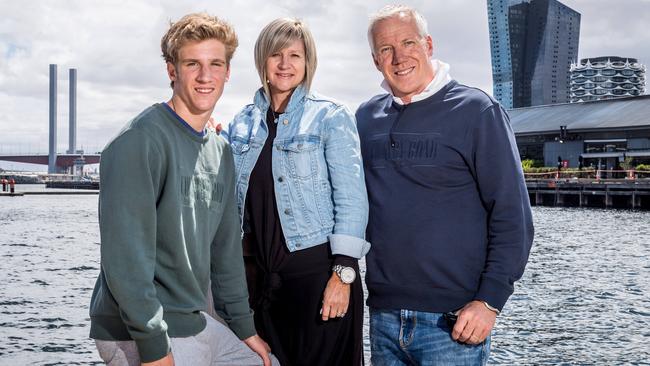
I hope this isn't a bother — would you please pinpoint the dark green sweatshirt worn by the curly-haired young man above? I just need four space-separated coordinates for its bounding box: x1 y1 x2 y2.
90 104 255 362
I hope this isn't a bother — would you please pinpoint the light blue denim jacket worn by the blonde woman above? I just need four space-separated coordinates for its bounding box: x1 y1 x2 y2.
222 85 370 258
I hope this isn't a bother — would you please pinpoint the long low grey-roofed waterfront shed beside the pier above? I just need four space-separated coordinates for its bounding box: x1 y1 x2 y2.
508 95 650 170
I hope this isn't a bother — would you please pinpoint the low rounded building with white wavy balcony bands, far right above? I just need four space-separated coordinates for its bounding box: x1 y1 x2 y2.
571 56 646 103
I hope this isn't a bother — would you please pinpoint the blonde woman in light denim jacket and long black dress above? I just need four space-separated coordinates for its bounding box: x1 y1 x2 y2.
223 18 370 366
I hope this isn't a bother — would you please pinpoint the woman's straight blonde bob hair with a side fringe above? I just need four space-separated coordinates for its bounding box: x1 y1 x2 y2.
255 18 318 98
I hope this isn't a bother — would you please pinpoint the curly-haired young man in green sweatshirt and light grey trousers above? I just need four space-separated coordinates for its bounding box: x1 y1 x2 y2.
90 14 271 365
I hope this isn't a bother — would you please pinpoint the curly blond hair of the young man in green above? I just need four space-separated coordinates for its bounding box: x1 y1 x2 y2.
160 13 239 88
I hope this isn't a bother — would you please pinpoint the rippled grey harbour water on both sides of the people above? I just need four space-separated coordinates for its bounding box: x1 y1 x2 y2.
0 186 650 365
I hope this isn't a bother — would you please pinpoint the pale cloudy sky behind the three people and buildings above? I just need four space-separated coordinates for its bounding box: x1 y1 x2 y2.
0 0 650 170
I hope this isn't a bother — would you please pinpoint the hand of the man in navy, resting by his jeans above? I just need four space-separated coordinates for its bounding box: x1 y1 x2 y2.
451 300 497 344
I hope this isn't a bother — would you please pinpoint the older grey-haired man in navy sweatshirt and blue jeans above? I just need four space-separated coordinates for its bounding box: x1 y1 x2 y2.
357 6 533 366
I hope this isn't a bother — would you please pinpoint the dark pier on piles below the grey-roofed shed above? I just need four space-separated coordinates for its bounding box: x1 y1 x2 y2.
526 178 650 210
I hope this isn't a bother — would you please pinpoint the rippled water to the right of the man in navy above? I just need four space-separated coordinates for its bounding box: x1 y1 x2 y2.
490 207 650 365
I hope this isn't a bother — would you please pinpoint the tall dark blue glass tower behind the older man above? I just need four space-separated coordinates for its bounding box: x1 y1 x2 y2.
487 0 580 108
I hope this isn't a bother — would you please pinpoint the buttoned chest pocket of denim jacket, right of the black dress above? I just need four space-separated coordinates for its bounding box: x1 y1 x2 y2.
276 135 321 179
